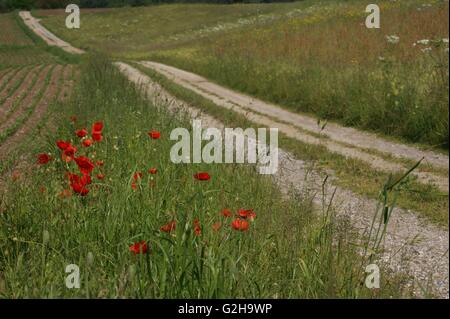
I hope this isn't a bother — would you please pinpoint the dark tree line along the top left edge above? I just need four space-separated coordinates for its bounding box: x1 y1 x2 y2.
0 0 293 12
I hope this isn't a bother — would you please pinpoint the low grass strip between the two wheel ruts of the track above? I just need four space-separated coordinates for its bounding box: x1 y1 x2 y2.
134 64 449 228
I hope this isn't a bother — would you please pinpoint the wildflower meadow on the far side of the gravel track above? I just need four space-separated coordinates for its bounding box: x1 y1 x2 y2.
36 0 449 150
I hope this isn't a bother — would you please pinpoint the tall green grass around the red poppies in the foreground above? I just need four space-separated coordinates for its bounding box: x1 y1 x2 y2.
0 57 409 298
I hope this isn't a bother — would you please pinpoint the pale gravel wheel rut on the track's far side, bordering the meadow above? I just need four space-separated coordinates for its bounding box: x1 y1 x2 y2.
141 62 449 192
